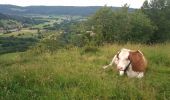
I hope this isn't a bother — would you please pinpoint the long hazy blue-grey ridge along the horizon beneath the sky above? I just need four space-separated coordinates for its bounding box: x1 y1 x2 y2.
0 5 134 15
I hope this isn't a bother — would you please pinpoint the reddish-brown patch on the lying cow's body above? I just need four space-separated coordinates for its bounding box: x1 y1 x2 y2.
129 51 147 72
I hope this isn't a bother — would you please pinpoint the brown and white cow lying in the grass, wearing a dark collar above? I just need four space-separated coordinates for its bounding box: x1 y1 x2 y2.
103 48 147 78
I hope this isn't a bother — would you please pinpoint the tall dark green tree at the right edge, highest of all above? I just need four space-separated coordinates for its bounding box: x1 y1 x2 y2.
141 0 170 42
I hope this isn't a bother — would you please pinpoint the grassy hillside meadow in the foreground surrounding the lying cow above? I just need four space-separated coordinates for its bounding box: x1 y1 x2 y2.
0 43 170 100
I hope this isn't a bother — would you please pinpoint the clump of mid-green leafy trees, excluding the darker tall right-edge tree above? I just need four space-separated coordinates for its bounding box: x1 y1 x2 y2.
85 4 156 44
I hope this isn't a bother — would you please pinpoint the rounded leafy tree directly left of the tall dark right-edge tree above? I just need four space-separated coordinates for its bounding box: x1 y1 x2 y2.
127 10 156 43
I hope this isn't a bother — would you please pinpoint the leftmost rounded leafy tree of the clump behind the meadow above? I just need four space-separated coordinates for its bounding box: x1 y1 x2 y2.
89 6 113 43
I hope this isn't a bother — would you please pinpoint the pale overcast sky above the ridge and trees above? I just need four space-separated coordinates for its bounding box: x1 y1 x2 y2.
0 0 145 8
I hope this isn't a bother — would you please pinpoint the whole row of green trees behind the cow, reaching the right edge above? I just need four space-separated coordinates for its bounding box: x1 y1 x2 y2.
59 0 170 46
